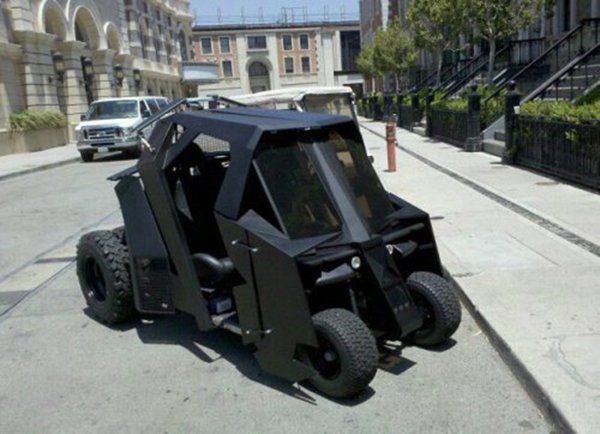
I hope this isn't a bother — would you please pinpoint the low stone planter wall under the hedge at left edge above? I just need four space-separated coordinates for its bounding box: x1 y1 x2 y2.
0 128 68 156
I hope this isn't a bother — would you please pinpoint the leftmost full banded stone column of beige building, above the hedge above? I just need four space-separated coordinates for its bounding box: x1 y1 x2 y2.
14 30 59 110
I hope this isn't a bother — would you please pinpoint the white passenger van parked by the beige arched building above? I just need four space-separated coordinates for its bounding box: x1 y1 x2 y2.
75 96 169 161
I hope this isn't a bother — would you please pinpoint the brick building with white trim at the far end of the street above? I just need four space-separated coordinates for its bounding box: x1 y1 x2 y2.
193 21 363 96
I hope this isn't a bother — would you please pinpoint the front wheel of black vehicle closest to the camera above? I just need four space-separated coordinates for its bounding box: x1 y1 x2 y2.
302 309 379 398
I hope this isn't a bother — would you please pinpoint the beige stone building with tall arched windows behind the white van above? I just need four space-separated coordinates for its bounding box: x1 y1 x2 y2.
0 0 193 137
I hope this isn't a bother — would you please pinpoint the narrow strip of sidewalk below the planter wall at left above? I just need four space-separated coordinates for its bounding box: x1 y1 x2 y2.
0 144 79 181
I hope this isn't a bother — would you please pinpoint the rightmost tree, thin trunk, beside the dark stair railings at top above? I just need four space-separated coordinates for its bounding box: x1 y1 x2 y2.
464 0 553 84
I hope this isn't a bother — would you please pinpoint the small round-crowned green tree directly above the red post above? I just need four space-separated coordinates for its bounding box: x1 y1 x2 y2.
373 19 417 89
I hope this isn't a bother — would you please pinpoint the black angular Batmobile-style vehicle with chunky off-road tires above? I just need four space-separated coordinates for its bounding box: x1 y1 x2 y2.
77 100 461 398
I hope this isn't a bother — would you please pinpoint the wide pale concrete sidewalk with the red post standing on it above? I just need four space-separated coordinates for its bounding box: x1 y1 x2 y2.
361 119 600 433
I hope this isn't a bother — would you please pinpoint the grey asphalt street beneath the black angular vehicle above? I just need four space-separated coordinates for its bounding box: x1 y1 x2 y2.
0 155 552 433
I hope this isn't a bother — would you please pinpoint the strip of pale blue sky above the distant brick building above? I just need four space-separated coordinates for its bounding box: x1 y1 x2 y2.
191 0 359 24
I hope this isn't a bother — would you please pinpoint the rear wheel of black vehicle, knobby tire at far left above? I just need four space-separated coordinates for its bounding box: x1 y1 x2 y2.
77 231 133 324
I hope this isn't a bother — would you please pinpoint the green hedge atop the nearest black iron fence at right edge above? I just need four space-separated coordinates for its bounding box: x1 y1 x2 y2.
519 100 600 124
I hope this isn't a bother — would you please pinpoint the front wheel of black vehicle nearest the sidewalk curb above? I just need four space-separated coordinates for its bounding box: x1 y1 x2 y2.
406 271 461 346
